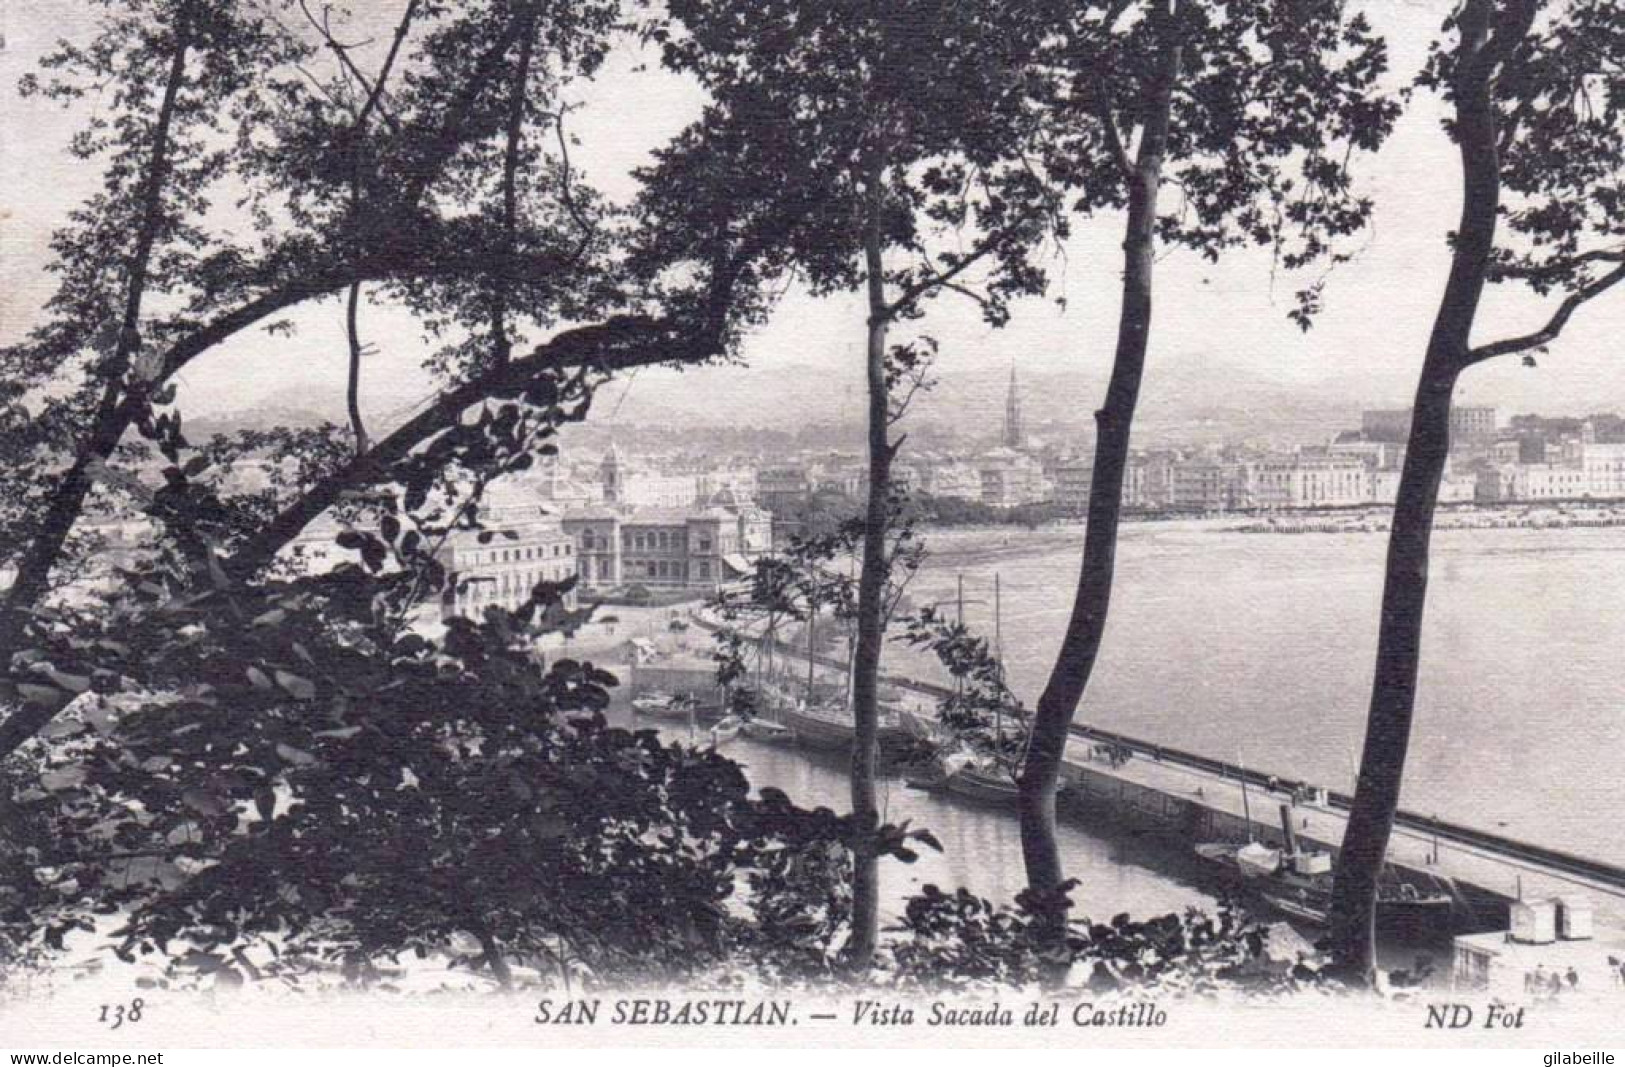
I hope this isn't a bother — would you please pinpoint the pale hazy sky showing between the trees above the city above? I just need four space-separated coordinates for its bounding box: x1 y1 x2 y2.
0 0 1625 444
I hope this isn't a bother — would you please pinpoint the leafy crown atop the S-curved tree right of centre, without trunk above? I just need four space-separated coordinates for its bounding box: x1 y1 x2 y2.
1040 0 1399 328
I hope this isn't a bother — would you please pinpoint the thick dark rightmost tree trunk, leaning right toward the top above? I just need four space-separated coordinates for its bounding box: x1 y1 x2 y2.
1331 0 1501 979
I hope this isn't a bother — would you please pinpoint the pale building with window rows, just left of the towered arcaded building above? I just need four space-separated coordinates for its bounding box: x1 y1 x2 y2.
436 490 579 619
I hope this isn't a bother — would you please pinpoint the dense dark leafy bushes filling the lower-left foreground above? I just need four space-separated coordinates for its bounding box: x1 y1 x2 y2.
0 545 949 981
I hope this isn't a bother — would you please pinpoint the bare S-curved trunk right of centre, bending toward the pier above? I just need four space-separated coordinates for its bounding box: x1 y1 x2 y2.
1019 14 1180 945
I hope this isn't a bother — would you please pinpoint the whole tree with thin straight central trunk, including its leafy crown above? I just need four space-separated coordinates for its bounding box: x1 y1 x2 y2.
650 0 1060 970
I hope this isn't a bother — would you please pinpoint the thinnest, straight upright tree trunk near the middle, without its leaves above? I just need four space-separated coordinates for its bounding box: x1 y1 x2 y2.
847 164 892 971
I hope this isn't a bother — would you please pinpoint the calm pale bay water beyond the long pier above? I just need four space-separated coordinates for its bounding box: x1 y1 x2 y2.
895 523 1625 862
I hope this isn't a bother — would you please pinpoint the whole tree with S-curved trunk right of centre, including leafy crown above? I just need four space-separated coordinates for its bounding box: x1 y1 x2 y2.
1021 0 1394 937
